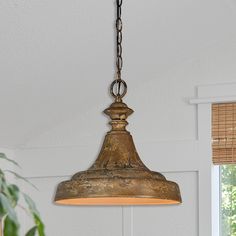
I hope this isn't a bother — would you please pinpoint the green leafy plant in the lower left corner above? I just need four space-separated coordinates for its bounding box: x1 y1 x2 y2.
0 153 45 236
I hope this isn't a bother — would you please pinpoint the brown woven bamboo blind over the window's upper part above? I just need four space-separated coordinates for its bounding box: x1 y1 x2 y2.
212 103 236 165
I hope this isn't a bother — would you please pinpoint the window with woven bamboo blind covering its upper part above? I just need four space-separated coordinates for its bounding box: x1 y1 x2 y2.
212 103 236 236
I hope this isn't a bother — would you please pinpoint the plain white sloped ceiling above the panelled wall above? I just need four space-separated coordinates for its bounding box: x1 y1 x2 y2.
0 0 236 147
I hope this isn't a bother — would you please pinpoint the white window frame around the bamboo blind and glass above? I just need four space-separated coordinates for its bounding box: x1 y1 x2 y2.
190 83 236 236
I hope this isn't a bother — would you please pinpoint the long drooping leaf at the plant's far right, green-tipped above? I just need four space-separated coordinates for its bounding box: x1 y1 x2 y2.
23 194 45 236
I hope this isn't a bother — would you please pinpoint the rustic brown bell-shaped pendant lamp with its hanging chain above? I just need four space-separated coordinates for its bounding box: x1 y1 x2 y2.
55 0 181 205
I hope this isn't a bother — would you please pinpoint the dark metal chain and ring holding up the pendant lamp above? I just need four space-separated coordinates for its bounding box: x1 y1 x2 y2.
110 0 127 99
